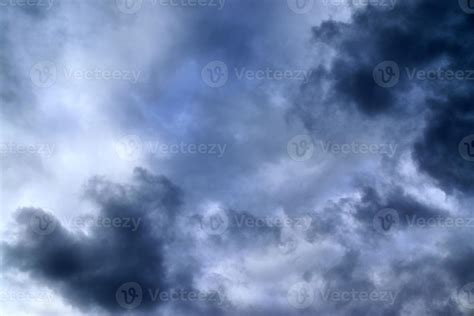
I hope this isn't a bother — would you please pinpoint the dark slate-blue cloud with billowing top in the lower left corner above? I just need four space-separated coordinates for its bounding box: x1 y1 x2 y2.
2 169 222 312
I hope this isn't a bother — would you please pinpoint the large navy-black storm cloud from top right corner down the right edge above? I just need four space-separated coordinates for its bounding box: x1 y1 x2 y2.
296 0 474 192
